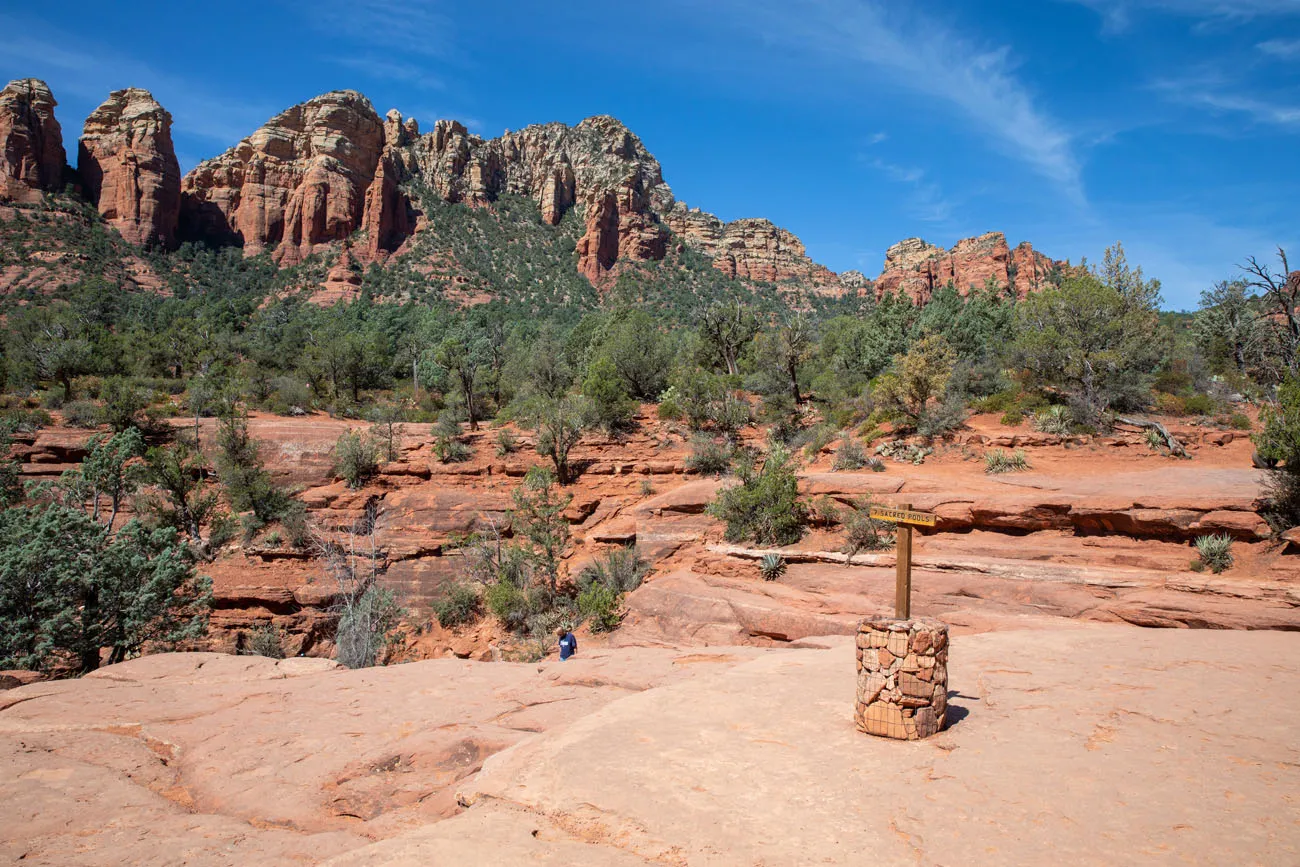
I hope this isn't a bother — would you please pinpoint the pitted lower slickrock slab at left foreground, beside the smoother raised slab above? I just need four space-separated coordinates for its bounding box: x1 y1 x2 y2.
0 649 761 866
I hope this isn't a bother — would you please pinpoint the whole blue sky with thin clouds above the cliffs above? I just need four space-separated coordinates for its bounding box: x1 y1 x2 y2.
0 0 1300 309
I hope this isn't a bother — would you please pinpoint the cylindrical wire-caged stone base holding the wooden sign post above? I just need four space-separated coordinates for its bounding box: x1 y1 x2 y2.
853 617 948 741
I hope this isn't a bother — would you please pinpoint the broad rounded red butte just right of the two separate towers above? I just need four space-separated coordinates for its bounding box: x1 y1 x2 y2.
181 91 385 264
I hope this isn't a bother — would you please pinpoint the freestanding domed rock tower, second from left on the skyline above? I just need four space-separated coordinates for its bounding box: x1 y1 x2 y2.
77 87 181 247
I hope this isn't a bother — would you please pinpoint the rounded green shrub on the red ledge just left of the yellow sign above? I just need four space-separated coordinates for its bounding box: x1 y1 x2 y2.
709 447 807 545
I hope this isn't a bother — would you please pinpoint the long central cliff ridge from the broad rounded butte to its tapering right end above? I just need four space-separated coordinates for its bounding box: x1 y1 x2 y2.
182 91 837 286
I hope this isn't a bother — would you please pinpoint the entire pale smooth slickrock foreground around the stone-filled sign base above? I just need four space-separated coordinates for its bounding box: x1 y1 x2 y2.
0 624 1300 867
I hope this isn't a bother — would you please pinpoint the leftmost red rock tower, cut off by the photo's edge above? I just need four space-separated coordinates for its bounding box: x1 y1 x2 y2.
0 78 66 201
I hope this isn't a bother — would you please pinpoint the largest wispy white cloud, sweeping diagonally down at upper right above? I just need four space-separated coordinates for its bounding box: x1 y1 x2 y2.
719 0 1086 204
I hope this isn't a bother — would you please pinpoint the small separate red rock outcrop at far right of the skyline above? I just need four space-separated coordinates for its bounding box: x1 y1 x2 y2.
875 231 1063 303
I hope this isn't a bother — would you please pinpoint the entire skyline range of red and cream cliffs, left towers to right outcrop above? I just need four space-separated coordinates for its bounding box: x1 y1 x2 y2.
0 79 1063 303
